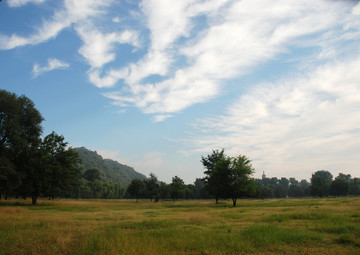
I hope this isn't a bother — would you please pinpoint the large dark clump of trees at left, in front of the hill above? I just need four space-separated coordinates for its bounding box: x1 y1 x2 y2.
0 90 80 204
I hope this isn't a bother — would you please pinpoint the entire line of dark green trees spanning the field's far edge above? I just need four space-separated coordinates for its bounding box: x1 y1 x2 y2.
0 90 360 206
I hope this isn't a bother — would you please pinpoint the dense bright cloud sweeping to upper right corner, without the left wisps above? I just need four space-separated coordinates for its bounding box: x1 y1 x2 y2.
103 0 360 120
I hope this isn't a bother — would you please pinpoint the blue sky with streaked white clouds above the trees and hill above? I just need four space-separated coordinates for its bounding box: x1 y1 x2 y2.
0 0 360 183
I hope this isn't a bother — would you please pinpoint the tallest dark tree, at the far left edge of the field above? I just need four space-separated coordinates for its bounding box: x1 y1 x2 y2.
0 90 43 204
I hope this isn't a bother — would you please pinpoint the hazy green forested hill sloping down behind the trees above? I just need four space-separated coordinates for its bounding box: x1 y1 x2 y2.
74 147 146 187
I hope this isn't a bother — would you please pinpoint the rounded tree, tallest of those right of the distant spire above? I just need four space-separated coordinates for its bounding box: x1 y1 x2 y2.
311 170 332 197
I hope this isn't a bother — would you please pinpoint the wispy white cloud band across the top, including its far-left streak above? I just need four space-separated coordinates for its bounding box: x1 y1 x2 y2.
0 0 360 126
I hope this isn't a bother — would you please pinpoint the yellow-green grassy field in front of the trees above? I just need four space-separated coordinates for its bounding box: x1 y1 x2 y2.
0 197 360 255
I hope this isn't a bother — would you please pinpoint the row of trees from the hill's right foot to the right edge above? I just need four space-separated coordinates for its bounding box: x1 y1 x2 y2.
126 150 360 206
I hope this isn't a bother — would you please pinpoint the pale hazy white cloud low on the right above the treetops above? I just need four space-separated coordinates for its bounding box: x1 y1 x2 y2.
191 57 360 178
